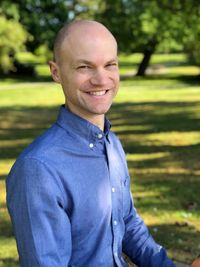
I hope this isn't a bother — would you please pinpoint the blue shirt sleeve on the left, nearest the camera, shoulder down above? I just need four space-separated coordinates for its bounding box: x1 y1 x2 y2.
7 158 72 267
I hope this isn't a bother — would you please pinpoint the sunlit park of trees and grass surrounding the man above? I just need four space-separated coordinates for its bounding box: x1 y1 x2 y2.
0 0 200 267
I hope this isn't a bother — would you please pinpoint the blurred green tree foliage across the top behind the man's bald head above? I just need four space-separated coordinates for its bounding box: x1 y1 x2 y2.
0 0 200 74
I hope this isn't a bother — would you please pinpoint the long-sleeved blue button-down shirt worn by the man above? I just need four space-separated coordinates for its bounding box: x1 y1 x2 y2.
7 107 175 267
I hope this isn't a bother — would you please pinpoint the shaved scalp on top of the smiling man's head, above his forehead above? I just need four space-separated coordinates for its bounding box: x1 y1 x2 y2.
53 20 117 62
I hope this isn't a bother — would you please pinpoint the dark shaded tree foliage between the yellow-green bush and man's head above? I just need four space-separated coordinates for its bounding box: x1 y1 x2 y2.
17 0 72 52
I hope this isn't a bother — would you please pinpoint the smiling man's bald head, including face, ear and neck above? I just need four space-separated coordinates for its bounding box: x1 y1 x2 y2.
50 20 119 129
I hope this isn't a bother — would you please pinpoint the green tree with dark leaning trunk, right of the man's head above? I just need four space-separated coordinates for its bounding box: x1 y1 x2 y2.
96 0 200 75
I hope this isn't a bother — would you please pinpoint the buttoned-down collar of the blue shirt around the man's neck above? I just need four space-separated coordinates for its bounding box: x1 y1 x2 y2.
57 105 111 142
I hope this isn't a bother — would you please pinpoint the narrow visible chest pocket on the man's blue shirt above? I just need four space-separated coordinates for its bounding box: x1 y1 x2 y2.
121 176 131 217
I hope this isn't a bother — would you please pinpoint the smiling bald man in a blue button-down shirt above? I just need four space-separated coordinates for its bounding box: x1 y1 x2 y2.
7 20 175 267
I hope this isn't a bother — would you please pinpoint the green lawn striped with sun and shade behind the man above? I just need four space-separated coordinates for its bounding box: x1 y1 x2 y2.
0 52 200 267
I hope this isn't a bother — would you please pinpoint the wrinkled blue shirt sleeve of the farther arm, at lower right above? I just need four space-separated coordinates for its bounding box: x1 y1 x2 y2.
123 194 175 267
